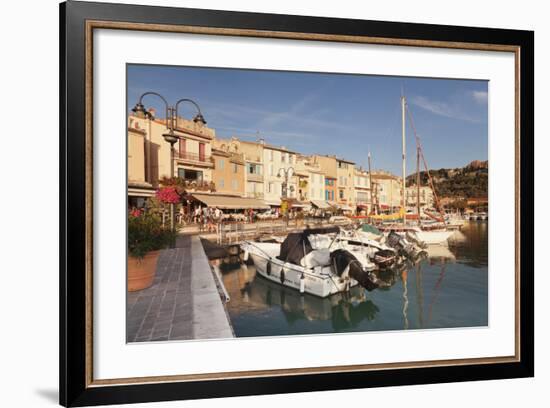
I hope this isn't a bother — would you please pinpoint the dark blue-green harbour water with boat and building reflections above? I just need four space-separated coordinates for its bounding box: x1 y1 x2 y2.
218 221 488 337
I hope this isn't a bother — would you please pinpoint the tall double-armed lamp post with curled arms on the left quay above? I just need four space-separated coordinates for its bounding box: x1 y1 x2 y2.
132 91 206 230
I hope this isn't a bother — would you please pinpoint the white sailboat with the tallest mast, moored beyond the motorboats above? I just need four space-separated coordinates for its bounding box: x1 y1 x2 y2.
380 95 454 245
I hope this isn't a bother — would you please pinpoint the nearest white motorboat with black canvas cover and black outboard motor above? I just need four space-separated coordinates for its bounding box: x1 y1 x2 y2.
241 227 383 297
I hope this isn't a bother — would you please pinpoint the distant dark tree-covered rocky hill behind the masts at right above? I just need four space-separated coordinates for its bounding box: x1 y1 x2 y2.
407 160 489 198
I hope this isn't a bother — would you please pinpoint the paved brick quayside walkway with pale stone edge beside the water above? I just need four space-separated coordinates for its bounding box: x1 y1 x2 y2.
126 236 234 342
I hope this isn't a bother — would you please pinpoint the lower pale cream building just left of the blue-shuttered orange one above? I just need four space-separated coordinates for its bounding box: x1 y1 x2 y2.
296 155 325 202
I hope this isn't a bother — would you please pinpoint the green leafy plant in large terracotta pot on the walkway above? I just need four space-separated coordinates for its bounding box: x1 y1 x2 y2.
128 210 176 292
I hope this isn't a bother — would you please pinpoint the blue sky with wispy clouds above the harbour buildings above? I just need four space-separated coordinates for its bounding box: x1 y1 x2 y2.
128 65 488 174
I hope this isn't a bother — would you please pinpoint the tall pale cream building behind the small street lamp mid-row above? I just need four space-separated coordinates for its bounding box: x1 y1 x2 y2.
259 139 298 207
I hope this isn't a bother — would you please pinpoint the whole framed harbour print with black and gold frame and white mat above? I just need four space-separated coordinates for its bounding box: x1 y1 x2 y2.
60 1 534 406
